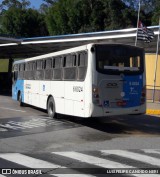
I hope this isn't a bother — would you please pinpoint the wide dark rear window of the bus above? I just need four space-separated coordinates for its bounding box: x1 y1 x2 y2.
96 45 144 74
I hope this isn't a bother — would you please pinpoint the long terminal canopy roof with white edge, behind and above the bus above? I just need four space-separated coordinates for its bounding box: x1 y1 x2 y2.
0 26 159 59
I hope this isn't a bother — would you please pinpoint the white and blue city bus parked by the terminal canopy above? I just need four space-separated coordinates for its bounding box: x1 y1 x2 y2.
12 44 146 117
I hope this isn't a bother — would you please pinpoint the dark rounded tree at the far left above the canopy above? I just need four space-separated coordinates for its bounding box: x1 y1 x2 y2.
1 7 48 37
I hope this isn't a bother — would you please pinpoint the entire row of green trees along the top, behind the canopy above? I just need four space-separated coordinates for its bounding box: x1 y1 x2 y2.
0 0 160 37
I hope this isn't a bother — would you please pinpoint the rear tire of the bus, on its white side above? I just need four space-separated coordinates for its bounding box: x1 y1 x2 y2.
47 97 56 118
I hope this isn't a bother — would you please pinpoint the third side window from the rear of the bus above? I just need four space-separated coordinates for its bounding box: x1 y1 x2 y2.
53 56 62 80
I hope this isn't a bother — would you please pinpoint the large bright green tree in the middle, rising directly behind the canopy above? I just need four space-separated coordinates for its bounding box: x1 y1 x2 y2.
46 0 125 35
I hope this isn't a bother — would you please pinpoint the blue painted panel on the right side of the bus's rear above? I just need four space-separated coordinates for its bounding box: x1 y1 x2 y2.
123 75 143 108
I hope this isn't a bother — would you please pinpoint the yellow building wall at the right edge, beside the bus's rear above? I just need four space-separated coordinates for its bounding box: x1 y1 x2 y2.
145 54 160 102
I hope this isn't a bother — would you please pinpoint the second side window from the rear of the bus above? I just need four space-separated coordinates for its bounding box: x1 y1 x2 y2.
63 54 76 80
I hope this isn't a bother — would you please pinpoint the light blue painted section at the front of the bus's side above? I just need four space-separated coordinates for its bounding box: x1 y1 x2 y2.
12 80 24 102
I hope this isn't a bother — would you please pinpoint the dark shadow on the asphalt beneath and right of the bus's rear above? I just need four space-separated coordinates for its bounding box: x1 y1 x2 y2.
63 115 160 135
